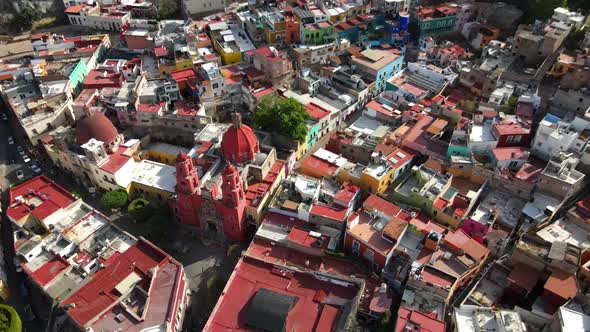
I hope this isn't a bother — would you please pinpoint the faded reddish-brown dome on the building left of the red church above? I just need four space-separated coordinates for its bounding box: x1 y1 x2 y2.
76 112 119 145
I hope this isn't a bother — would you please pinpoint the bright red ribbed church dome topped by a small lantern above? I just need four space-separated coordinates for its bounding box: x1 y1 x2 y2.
221 113 260 164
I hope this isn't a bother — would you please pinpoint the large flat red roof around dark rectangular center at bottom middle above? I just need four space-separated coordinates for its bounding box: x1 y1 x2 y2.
205 256 360 332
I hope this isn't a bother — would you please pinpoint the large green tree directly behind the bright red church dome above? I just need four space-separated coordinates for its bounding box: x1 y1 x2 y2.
254 96 309 143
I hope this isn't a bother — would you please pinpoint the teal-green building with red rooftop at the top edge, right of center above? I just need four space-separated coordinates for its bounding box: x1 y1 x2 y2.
410 5 457 40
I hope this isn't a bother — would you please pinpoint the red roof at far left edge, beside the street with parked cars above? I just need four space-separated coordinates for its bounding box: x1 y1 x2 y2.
6 175 76 221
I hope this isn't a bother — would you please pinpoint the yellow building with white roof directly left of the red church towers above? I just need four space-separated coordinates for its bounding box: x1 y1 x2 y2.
127 160 176 206
